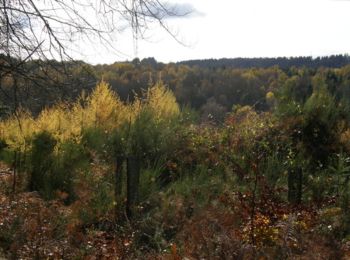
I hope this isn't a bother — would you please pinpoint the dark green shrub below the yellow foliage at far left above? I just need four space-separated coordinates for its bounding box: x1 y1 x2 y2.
29 132 89 203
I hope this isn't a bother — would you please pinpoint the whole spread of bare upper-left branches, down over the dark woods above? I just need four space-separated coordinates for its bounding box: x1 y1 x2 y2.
0 0 191 114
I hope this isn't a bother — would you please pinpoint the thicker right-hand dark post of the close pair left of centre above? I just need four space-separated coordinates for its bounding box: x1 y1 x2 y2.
126 156 140 219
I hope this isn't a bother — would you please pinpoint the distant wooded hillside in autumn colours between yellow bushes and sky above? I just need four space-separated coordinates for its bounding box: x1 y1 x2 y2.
0 55 350 121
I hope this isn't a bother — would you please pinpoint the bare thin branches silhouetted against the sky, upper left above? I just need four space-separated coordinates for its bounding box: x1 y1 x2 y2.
0 0 192 60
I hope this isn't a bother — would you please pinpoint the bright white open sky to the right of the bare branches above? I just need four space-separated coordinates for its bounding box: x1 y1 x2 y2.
76 0 350 64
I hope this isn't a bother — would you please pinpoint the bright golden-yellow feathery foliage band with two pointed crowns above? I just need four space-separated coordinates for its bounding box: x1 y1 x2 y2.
0 81 180 150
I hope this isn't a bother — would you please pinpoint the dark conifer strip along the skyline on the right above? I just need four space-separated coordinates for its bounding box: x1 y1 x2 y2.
177 55 350 69
